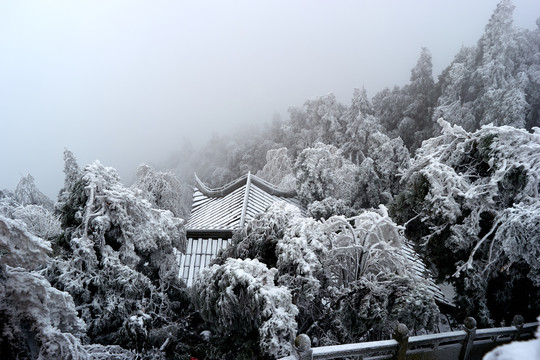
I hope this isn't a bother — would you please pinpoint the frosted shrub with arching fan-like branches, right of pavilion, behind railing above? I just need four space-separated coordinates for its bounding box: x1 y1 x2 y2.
314 206 439 344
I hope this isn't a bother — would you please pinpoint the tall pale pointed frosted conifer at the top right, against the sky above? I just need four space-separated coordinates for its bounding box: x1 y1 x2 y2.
434 0 535 131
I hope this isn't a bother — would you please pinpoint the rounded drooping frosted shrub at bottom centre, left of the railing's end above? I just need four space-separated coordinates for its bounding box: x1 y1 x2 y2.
192 258 298 356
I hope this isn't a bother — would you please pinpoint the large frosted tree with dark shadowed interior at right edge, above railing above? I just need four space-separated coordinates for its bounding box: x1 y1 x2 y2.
393 119 540 324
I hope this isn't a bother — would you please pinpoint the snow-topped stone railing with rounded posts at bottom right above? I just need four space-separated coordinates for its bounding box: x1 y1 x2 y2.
278 315 538 360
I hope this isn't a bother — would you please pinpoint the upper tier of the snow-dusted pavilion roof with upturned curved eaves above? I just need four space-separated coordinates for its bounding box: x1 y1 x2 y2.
186 173 305 237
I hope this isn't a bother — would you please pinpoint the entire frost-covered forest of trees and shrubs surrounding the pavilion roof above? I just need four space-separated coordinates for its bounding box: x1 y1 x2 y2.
0 0 540 359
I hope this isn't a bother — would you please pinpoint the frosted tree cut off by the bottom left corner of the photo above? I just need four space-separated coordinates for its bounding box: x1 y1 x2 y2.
0 216 88 359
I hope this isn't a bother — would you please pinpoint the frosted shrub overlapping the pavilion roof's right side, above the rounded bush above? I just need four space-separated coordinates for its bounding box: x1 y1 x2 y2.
215 202 326 334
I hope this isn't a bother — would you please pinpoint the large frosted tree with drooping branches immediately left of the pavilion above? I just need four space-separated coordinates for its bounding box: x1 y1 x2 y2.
47 161 185 351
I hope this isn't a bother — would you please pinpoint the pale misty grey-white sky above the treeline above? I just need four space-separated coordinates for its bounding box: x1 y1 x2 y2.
0 0 540 199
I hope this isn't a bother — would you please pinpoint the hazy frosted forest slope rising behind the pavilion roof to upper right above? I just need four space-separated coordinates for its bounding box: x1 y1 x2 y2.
176 1 540 194
